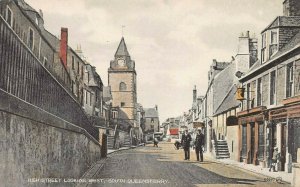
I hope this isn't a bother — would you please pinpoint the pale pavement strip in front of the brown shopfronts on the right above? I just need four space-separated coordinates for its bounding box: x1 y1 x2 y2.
202 151 293 183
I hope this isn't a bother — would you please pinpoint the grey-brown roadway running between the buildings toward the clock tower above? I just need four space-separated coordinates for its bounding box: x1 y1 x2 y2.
88 142 290 187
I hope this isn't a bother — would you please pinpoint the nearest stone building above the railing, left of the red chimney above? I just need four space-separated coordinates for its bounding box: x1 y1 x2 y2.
0 0 71 91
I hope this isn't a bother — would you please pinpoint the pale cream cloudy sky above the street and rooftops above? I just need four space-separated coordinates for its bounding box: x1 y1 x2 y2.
25 0 283 122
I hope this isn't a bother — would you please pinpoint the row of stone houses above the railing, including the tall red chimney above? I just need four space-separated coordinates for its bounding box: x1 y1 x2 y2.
0 0 103 131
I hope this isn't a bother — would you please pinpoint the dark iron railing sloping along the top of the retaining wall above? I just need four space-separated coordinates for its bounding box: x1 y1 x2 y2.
0 15 99 140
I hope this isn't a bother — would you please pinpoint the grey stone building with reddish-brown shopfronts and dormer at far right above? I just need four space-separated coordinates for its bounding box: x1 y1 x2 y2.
238 0 300 172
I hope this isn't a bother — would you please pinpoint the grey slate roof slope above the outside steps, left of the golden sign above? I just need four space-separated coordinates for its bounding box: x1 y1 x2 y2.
214 85 240 115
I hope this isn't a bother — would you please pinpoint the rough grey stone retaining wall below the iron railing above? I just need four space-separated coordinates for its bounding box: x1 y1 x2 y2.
0 90 101 187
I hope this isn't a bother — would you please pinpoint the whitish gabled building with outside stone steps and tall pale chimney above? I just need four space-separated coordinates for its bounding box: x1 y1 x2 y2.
199 31 258 157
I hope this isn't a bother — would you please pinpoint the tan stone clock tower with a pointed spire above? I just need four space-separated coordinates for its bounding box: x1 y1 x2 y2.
108 37 137 130
